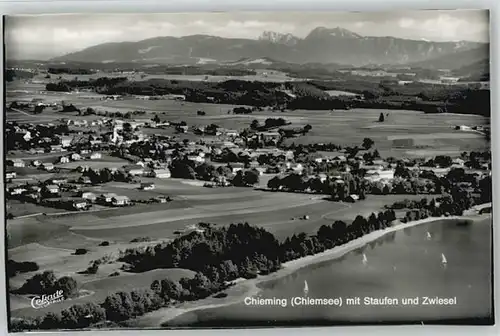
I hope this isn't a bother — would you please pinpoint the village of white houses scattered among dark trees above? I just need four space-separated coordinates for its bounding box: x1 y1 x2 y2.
5 101 491 218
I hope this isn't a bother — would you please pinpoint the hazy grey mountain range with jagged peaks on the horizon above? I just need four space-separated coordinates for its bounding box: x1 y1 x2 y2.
51 27 488 66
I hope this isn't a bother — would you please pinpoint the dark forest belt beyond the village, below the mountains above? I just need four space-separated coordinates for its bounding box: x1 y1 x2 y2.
46 77 490 115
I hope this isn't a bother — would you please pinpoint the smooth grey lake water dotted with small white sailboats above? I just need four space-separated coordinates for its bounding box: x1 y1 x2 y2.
169 218 493 327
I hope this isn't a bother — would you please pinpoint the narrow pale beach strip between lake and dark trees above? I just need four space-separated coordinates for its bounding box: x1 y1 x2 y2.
130 203 491 328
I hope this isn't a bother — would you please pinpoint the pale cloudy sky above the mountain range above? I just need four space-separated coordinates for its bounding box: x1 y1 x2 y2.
5 10 489 60
